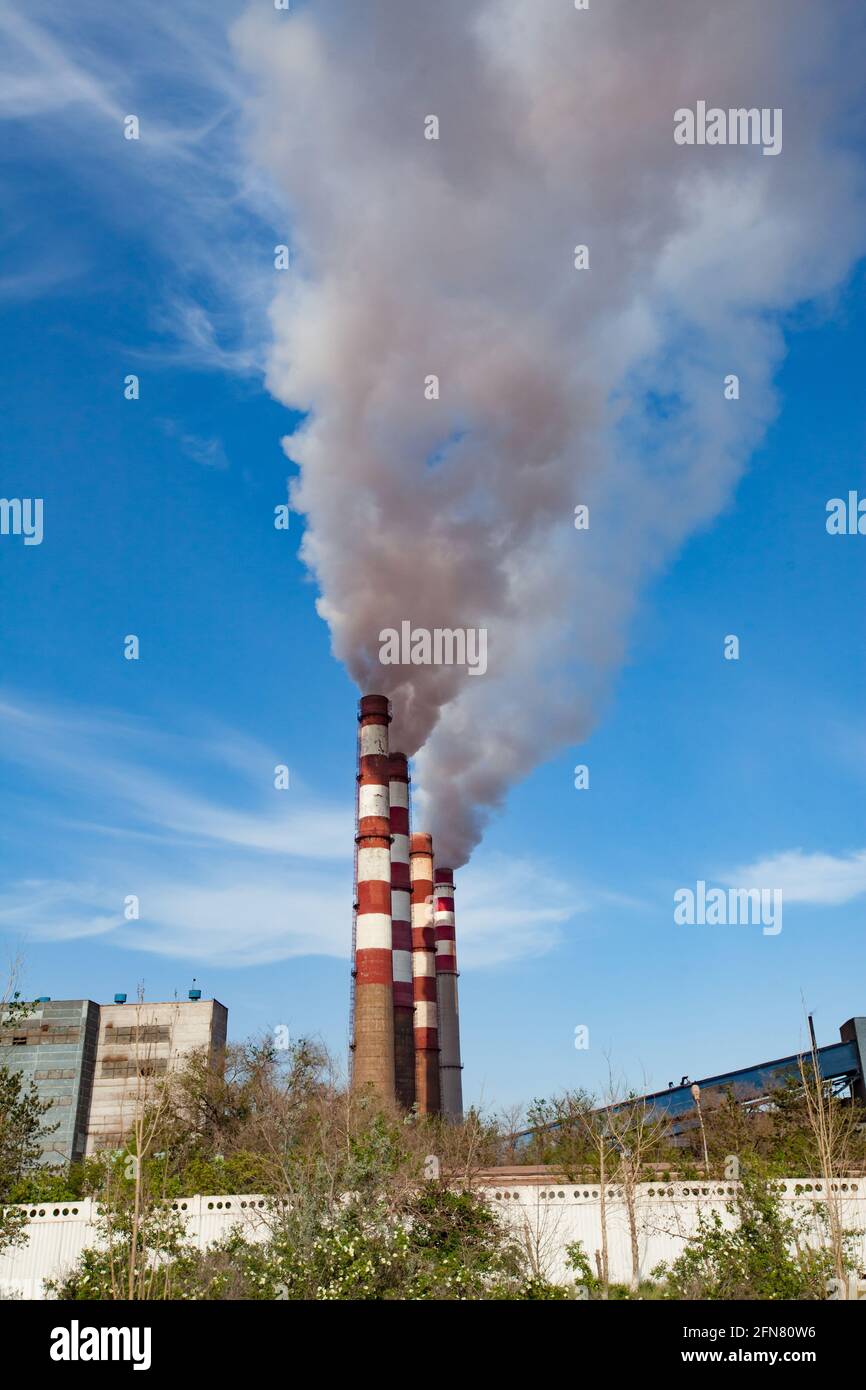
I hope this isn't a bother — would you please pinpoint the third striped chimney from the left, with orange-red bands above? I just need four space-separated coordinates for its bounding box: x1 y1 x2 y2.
409 835 441 1115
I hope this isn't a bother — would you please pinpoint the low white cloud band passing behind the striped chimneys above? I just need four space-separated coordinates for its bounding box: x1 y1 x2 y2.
0 841 594 969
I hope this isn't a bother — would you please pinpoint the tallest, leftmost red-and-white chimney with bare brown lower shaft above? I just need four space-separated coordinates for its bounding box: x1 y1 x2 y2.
352 695 395 1101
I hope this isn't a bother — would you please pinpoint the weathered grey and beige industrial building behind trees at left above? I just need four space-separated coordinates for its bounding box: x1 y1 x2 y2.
0 990 228 1166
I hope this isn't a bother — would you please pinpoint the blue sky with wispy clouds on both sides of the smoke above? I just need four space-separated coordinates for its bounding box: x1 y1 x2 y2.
0 6 866 1108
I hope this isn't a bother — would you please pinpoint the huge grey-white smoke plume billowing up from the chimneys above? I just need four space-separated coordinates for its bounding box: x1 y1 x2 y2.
234 0 865 865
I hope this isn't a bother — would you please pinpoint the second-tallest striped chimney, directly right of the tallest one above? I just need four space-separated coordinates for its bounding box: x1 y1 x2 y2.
391 753 416 1109
